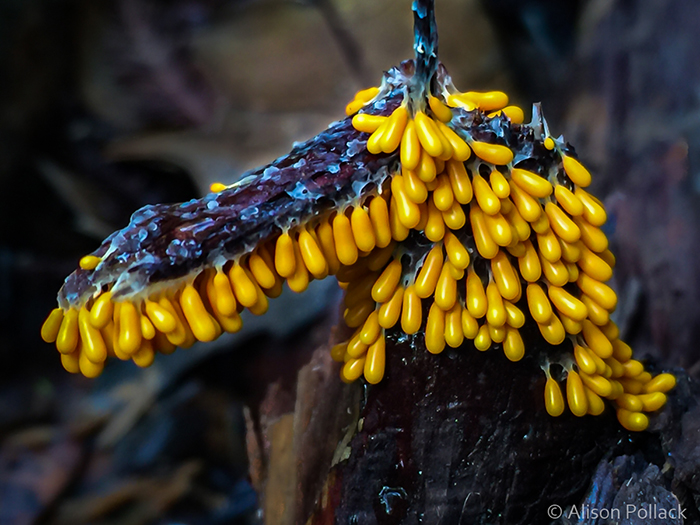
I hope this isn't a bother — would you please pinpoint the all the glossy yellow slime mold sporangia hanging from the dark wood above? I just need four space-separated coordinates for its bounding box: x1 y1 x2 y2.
42 81 675 430
